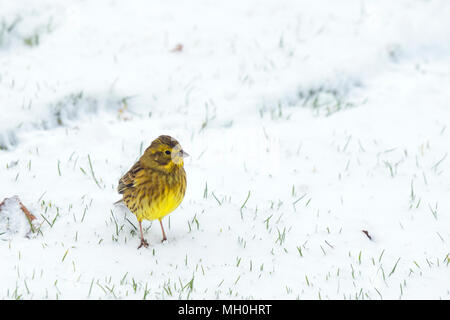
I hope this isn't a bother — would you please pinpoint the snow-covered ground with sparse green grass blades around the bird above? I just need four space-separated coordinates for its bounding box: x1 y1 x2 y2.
0 0 450 299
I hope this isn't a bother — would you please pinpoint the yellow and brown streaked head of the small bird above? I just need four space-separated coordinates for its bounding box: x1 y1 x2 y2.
141 135 189 171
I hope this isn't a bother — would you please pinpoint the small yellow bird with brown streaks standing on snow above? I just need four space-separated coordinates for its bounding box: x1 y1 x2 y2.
117 136 188 249
